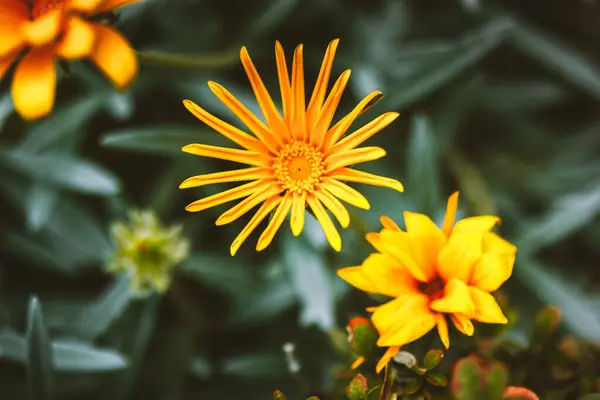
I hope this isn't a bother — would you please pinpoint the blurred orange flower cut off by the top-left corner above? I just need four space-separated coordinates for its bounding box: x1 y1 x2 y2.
0 0 138 120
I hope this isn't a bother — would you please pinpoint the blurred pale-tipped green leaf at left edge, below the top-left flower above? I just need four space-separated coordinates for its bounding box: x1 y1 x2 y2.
2 151 121 196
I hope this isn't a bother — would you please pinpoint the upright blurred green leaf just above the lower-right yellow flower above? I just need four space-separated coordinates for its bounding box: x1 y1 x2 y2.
406 114 442 215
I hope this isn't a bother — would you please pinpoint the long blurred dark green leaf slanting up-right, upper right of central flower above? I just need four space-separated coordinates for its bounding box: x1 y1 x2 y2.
382 18 512 109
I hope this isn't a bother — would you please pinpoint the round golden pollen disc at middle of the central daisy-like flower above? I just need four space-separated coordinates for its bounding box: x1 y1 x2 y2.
273 141 325 194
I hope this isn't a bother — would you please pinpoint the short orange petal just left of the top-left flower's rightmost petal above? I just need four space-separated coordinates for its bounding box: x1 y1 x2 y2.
55 16 96 59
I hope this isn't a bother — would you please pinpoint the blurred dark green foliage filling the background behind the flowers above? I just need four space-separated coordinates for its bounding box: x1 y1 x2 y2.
0 0 600 400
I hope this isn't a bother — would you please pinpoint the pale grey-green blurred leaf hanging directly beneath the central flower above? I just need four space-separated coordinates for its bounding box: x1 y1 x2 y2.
283 231 335 330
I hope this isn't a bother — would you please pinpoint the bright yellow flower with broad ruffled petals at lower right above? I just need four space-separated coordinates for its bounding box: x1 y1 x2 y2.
338 192 517 372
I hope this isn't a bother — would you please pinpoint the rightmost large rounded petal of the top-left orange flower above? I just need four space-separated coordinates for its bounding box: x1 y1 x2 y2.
91 24 138 89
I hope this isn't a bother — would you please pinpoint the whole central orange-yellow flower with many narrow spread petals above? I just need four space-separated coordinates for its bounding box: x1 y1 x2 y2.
179 39 403 255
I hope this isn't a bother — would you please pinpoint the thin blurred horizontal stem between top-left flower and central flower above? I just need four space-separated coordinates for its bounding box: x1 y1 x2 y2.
137 50 238 70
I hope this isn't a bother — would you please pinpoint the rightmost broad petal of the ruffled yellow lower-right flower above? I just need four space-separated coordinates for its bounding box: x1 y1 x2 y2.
469 253 515 292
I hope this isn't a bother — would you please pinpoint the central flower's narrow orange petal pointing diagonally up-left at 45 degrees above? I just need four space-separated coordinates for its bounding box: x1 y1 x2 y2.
208 81 278 153
